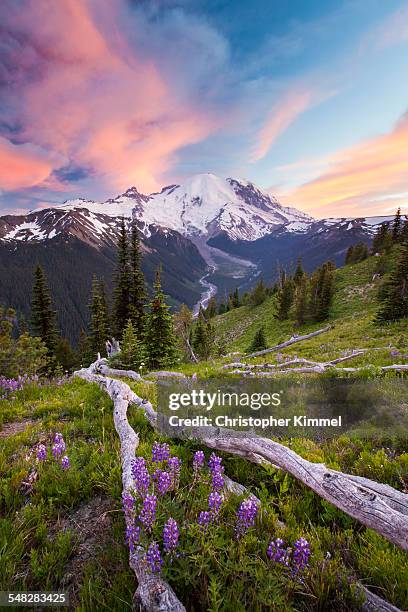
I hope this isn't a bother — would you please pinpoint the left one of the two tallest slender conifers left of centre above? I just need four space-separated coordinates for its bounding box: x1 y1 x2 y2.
113 217 131 338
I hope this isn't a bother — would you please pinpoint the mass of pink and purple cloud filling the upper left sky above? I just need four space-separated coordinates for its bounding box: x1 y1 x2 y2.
0 0 228 196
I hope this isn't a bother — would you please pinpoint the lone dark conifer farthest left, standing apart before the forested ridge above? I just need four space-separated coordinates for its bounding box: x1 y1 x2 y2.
31 265 58 355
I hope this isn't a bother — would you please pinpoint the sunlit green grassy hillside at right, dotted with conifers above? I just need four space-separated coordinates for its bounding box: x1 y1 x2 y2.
209 251 408 365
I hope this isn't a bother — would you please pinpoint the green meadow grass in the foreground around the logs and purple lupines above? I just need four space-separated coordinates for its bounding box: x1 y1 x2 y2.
0 379 408 611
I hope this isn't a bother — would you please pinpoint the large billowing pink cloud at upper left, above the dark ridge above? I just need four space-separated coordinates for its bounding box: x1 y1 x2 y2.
0 0 220 191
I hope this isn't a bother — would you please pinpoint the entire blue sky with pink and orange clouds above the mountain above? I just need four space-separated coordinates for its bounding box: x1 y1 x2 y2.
0 0 408 218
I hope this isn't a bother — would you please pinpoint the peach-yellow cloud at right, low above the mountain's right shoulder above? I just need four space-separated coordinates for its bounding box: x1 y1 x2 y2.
285 114 408 217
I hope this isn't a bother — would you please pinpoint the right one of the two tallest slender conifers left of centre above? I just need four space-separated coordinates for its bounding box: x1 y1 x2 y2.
129 223 147 338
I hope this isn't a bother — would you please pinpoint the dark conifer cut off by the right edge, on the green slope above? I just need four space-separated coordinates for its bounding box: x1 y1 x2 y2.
376 241 408 322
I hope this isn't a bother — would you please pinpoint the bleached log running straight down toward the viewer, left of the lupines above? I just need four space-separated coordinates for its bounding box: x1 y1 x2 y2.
75 362 185 612
